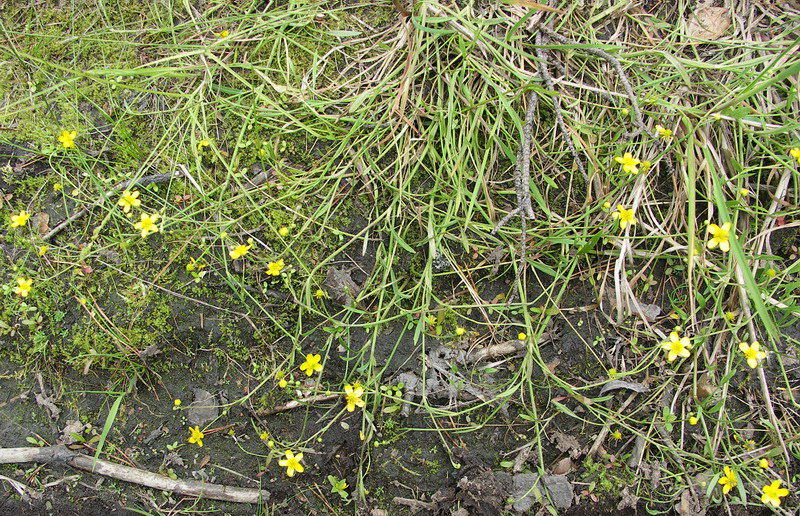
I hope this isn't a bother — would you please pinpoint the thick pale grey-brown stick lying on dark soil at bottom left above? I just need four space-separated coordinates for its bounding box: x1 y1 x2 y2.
0 445 269 503
